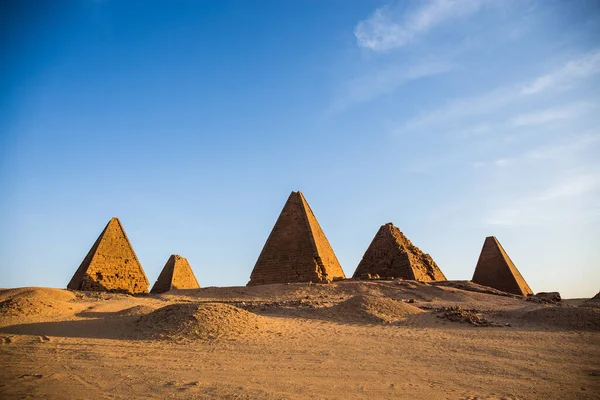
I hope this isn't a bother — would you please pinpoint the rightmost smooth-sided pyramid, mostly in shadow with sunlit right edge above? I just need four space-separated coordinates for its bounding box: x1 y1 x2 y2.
472 236 533 296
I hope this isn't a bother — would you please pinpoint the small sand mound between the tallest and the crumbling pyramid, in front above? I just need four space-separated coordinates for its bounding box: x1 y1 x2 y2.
326 295 423 323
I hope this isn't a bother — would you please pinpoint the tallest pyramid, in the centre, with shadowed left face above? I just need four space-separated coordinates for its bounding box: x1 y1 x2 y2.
248 192 346 285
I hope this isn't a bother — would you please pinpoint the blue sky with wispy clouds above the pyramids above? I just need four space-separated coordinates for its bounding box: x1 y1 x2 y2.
0 0 600 297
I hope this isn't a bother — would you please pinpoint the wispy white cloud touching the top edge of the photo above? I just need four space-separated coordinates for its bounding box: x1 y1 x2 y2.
354 0 489 52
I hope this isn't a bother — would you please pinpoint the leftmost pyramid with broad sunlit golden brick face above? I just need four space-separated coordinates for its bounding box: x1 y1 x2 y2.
67 218 149 294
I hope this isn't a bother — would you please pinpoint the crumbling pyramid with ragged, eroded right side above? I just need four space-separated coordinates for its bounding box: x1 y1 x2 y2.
353 222 446 282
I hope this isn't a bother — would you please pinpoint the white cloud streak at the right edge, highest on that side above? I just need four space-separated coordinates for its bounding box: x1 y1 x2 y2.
521 50 600 95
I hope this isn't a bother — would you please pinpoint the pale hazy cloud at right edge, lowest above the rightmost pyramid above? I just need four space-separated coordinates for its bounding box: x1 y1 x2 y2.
484 173 600 226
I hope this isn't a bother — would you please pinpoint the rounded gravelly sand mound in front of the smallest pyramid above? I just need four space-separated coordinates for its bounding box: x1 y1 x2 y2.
136 303 264 340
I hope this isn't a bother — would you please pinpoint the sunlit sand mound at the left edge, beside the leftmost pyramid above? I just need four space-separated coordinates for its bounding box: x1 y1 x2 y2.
0 287 75 317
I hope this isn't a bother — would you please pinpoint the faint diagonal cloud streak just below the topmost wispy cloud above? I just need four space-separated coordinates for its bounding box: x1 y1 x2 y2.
330 62 454 113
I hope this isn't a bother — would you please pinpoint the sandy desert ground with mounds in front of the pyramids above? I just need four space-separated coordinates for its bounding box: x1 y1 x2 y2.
0 280 600 399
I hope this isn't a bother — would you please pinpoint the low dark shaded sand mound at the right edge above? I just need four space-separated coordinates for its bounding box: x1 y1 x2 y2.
521 307 600 331
